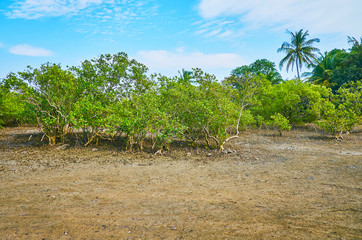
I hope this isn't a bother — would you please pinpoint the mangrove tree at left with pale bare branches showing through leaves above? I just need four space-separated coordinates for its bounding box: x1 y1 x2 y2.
18 63 77 145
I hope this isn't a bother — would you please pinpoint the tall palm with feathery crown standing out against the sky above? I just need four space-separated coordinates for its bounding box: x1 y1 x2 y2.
278 29 319 78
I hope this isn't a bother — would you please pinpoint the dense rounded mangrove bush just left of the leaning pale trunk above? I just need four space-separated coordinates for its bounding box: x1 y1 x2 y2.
160 69 237 148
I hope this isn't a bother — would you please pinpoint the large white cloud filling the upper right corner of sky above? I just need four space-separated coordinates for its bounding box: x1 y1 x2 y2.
198 0 362 36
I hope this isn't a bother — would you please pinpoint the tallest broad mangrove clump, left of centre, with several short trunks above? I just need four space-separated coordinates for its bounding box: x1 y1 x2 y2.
72 53 188 151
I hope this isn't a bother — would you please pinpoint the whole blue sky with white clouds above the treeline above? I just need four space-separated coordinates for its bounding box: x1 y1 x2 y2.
0 0 362 79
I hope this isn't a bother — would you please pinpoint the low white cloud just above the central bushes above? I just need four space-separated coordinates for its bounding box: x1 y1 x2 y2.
135 49 246 79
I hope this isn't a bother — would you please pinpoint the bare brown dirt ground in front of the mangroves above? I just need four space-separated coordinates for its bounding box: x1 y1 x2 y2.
0 127 362 239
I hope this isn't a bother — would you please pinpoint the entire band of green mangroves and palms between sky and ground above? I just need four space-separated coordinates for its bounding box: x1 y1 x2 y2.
0 30 362 151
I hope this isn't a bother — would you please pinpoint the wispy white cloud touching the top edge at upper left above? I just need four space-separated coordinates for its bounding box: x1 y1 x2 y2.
7 0 102 19
